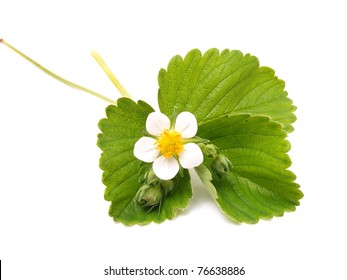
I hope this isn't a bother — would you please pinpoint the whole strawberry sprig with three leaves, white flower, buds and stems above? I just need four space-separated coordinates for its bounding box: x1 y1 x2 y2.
0 39 303 225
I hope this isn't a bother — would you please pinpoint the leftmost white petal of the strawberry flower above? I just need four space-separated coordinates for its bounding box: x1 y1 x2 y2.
134 137 159 162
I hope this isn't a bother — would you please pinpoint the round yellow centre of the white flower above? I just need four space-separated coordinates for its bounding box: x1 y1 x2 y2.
156 129 183 158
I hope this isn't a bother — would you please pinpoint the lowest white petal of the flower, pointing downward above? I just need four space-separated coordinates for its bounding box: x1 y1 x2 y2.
153 156 180 180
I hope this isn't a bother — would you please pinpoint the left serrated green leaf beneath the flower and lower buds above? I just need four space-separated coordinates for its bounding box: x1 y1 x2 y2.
98 98 191 225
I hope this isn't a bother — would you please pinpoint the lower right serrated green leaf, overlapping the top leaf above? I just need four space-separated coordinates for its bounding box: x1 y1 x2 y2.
198 114 303 223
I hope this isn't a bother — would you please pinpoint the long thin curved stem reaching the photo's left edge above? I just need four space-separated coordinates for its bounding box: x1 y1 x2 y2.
0 39 117 104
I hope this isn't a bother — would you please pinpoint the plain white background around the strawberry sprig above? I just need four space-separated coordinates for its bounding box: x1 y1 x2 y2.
0 0 347 280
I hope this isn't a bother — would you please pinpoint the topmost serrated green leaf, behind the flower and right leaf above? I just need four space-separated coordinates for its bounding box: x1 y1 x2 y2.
158 49 296 132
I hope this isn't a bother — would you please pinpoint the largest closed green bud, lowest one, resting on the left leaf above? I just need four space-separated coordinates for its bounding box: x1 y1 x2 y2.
135 184 163 207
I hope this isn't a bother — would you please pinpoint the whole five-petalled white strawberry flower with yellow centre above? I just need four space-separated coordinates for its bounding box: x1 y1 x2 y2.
134 112 203 180
